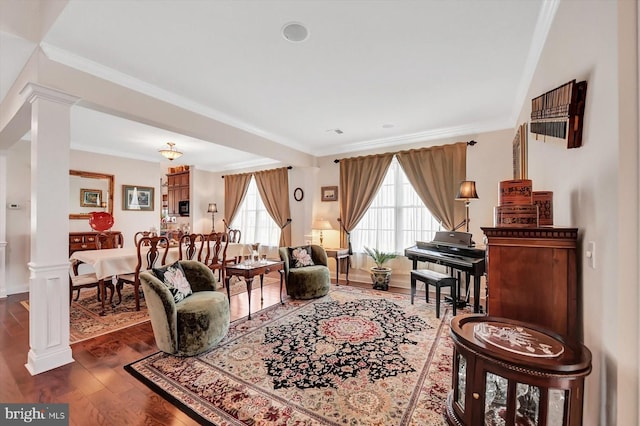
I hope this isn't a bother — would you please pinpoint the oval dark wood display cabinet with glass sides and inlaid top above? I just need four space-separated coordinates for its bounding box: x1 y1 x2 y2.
445 314 591 426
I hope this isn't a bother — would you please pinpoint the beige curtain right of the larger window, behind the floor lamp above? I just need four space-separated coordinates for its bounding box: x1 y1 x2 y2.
396 142 467 230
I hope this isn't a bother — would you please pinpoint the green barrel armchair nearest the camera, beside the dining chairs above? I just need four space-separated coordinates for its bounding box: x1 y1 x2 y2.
140 260 230 356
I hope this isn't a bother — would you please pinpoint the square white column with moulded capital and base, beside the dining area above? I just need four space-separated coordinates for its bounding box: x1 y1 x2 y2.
21 83 78 374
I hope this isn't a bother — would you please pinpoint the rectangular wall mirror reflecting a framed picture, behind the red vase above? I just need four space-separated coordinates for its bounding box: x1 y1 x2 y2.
69 170 113 219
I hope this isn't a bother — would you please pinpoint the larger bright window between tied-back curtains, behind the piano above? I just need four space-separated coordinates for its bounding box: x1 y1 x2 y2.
351 157 442 253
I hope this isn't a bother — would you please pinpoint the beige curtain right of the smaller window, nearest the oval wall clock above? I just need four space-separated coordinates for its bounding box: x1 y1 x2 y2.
254 167 291 247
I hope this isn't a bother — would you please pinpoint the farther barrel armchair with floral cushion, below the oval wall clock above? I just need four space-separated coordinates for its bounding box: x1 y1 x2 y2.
279 244 331 299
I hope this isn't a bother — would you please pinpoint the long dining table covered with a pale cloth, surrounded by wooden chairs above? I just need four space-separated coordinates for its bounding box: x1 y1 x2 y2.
69 243 251 316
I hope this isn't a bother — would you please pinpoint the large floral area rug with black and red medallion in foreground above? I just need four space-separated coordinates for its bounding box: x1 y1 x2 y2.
125 286 453 426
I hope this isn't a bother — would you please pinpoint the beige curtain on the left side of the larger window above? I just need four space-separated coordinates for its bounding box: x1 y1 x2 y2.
339 153 393 253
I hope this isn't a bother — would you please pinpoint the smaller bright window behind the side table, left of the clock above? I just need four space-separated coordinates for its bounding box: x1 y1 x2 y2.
231 177 280 247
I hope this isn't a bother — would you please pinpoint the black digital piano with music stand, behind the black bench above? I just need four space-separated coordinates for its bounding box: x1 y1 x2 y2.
404 231 486 313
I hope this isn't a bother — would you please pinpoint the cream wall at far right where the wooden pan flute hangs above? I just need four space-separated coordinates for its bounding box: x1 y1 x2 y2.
519 1 638 425
